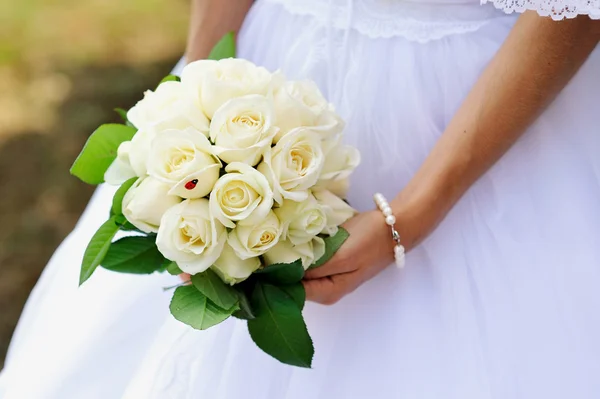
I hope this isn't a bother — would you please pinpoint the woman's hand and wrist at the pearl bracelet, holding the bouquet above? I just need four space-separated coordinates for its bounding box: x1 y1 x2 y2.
303 205 424 305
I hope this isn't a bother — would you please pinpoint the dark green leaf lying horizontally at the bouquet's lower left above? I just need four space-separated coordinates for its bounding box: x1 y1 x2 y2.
102 235 166 274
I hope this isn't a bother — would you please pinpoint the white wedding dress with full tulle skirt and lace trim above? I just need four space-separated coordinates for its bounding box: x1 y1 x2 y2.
0 0 600 399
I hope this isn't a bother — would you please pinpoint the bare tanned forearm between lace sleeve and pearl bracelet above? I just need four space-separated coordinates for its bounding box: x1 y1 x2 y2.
392 13 600 247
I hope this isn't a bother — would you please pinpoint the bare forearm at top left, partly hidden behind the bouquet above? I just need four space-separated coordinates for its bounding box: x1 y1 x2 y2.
186 0 253 62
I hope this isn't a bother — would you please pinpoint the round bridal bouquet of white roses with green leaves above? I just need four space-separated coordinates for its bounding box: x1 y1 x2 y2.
71 35 359 367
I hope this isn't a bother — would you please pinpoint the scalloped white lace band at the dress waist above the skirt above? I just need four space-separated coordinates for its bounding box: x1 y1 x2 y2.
264 0 498 43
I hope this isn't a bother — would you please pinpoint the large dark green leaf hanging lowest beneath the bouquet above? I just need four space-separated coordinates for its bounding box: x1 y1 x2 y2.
248 283 314 367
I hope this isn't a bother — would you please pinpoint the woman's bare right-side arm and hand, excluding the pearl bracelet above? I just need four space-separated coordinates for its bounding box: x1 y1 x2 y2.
304 12 600 304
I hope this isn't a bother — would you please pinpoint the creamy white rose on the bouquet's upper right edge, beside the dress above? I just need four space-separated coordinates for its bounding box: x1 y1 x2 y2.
273 80 343 142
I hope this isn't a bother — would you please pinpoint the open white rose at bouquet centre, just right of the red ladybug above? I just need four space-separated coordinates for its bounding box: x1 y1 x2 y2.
210 162 273 228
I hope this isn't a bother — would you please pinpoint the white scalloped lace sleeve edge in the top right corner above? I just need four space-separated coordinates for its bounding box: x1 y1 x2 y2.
481 0 600 21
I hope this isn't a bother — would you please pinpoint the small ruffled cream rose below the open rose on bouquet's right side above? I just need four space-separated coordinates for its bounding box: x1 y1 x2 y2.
274 194 327 245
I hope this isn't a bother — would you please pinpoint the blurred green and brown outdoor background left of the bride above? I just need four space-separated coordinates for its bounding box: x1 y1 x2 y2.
0 0 189 369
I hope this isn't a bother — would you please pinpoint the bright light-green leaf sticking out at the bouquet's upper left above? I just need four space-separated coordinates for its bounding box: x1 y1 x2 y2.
71 124 136 184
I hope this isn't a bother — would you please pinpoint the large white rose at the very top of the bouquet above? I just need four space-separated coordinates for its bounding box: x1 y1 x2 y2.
181 58 272 119
